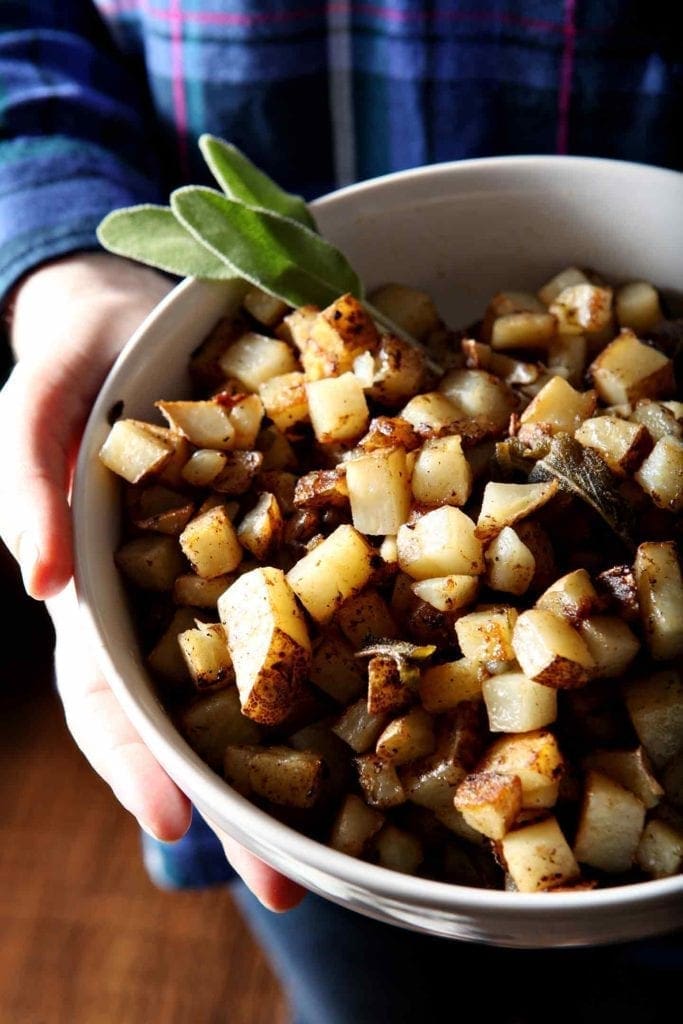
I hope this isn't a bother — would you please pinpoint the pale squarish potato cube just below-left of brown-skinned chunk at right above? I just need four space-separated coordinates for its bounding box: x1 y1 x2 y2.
483 672 557 737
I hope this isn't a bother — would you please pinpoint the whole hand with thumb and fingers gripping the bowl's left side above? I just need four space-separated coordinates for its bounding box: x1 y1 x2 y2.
0 253 302 909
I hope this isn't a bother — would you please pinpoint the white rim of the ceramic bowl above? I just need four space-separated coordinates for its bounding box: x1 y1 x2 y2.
73 155 683 927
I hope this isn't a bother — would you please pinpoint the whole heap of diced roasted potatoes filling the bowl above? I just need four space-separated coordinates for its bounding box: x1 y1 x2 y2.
100 276 683 892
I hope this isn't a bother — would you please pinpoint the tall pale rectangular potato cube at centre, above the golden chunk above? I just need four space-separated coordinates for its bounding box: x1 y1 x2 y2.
346 447 411 536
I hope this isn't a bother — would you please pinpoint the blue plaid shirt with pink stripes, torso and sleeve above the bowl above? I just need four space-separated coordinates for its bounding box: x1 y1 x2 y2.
0 0 683 296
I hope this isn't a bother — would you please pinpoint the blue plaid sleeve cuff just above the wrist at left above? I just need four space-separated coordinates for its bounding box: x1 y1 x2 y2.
0 135 161 304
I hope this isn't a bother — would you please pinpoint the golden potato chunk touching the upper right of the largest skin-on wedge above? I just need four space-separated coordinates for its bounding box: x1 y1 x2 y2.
287 523 375 623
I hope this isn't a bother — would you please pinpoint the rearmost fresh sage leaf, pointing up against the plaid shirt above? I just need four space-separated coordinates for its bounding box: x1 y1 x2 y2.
200 134 316 231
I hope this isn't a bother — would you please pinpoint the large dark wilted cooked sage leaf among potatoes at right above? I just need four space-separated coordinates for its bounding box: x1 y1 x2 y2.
528 433 636 549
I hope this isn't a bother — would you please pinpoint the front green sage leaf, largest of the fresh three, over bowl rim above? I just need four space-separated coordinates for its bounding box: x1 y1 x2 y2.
171 185 362 306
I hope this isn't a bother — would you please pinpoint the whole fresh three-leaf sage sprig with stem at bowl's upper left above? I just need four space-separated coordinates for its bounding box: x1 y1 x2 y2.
97 134 440 364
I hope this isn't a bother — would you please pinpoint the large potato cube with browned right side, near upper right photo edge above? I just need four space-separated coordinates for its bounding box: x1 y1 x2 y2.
590 329 674 406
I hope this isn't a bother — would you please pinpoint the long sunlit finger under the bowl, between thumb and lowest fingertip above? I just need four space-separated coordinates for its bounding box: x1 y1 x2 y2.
48 587 191 842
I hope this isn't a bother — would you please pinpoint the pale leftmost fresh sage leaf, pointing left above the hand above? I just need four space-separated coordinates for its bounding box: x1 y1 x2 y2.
97 204 238 281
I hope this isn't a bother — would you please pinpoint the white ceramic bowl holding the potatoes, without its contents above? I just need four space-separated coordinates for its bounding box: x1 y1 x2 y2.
74 157 683 947
